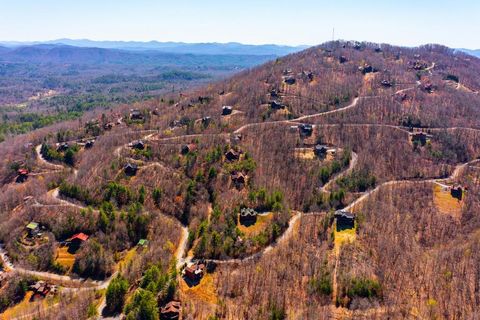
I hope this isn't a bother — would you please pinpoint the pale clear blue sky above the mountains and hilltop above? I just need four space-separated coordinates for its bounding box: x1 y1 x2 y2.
0 0 480 49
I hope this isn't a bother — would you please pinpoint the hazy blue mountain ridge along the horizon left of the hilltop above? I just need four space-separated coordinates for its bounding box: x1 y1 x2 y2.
0 39 308 56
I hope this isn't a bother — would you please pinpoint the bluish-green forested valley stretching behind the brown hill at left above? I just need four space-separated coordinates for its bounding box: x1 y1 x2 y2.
0 44 275 141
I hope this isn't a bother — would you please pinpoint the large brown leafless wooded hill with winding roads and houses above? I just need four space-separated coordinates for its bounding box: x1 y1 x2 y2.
0 41 480 319
